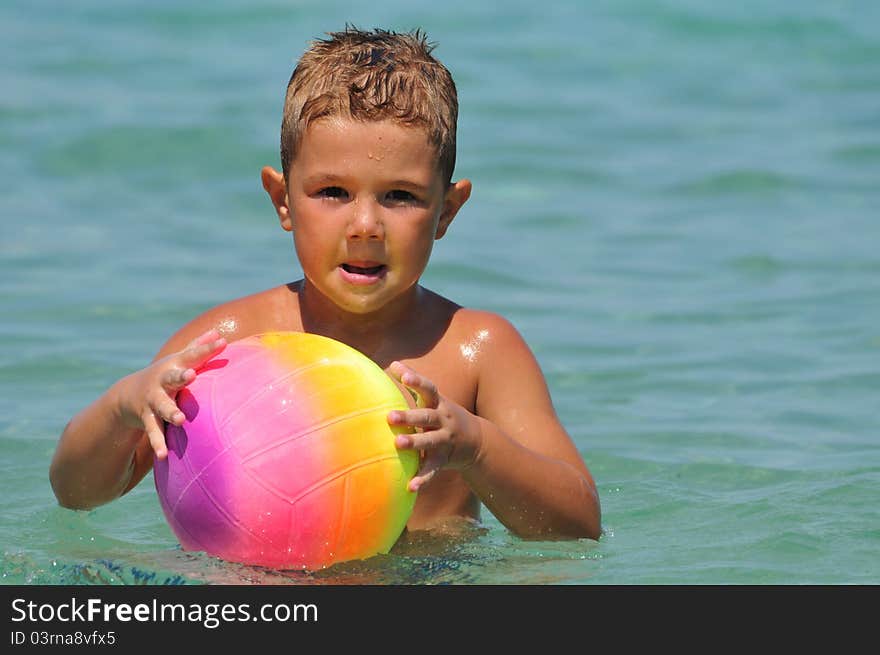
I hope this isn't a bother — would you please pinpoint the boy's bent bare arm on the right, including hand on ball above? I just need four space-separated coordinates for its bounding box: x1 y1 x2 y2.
390 317 601 539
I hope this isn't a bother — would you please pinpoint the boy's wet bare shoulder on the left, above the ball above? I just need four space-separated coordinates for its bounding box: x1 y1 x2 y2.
156 284 302 358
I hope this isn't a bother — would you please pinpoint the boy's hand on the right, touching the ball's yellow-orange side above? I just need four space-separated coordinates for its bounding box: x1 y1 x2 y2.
388 362 481 491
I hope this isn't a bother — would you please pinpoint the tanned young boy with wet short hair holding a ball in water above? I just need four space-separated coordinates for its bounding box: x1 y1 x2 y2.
50 28 601 539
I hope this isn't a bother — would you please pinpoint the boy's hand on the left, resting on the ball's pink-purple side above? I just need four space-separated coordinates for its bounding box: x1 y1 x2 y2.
119 329 226 459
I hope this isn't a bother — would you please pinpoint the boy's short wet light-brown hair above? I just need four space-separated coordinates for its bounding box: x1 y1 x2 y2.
281 27 458 184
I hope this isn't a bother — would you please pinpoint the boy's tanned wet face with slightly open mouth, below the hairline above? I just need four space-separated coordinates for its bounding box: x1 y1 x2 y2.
276 119 470 314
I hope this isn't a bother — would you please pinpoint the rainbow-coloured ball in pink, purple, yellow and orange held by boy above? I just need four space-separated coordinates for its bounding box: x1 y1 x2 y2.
154 332 418 570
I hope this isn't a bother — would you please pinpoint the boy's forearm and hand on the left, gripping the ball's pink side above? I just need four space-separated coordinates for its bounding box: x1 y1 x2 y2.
49 326 225 509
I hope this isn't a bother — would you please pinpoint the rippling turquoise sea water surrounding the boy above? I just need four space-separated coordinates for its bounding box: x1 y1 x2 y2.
0 0 880 584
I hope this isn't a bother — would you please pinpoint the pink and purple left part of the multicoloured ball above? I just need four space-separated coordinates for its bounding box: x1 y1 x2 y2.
155 343 320 563
